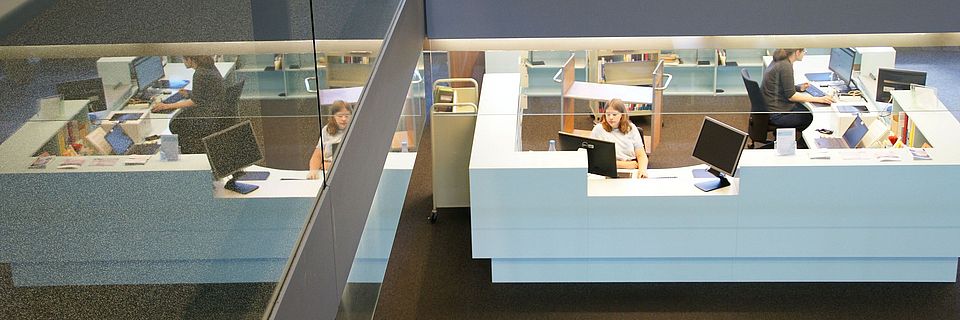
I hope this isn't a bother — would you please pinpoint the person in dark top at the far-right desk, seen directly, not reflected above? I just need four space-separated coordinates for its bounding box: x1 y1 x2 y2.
760 48 834 145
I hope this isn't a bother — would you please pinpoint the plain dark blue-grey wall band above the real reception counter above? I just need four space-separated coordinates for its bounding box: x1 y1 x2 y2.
425 0 960 39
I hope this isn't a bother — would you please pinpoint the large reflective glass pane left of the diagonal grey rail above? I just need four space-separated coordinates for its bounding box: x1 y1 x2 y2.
0 1 402 319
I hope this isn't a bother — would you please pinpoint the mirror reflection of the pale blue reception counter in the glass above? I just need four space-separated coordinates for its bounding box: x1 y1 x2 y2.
0 97 416 286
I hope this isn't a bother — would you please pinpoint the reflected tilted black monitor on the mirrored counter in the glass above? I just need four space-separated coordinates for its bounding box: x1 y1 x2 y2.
203 120 263 194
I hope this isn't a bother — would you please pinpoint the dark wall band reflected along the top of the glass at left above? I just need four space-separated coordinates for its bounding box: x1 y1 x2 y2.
0 0 400 45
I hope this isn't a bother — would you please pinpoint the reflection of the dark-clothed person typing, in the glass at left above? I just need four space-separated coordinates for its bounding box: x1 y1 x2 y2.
153 56 226 117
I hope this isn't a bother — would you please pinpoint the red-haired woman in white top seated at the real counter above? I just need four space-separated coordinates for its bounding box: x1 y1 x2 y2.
590 99 648 178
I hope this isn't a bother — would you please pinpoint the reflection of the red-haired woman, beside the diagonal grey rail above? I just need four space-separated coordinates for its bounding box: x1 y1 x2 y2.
307 100 353 179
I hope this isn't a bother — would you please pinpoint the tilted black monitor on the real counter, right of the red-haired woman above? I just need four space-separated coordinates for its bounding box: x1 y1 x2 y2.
693 117 747 191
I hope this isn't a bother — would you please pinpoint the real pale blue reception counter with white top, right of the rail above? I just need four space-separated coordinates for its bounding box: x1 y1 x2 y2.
469 74 960 282
